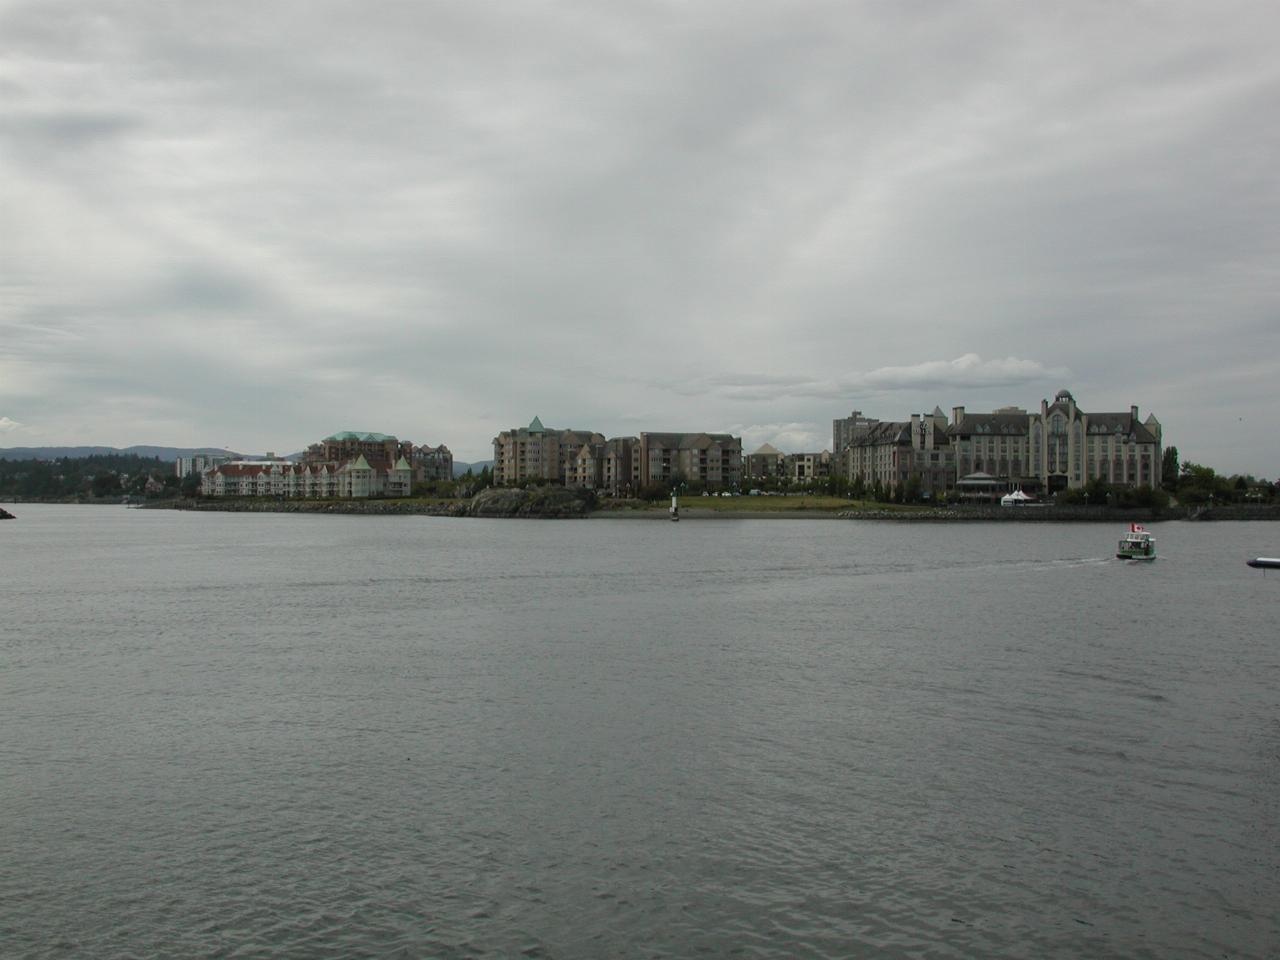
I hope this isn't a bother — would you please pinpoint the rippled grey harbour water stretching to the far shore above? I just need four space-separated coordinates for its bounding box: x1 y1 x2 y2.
0 504 1280 957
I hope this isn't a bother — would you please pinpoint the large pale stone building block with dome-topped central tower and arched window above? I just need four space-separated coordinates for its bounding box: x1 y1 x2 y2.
947 390 1162 494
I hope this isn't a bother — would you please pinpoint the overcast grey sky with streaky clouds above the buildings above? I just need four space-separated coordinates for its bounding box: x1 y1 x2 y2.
0 0 1280 479
